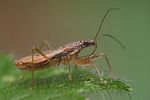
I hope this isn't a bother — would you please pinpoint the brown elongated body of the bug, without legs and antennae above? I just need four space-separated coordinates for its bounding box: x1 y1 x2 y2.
15 40 96 71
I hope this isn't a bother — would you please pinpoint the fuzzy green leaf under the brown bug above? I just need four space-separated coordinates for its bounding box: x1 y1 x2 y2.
0 55 133 100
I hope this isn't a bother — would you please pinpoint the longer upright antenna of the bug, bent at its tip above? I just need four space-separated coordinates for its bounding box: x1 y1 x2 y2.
94 8 120 40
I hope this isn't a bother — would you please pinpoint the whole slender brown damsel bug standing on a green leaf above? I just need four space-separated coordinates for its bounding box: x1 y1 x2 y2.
15 8 125 86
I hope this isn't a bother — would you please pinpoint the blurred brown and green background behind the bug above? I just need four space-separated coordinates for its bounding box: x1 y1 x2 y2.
0 0 150 100
